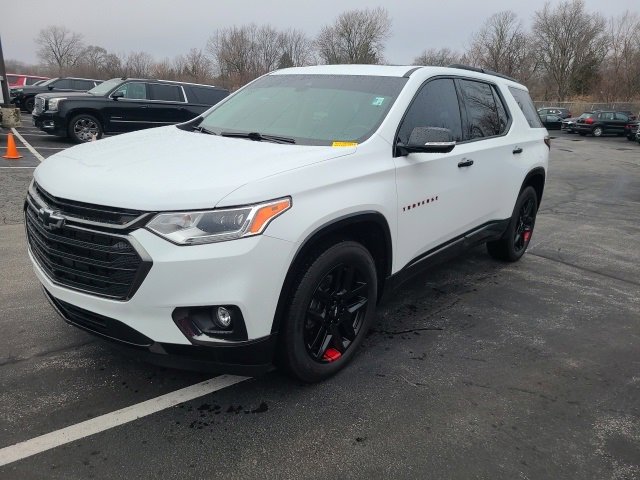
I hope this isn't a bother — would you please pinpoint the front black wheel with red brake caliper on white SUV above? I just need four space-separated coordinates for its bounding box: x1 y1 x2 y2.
279 241 378 383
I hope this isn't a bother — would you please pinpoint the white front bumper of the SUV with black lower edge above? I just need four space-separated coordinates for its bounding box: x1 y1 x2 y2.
29 229 296 373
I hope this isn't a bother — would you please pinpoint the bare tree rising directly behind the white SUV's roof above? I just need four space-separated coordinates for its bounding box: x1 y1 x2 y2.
316 7 391 63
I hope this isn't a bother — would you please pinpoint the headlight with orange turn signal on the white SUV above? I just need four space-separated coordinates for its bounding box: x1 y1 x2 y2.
147 198 291 245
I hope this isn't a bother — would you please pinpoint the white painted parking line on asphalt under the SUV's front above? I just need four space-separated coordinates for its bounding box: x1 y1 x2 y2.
0 375 250 467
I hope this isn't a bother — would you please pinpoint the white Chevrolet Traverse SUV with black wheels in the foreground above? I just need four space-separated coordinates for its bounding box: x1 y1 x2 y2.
25 65 549 382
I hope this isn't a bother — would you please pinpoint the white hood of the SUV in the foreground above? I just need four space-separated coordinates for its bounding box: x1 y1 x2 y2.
34 126 356 211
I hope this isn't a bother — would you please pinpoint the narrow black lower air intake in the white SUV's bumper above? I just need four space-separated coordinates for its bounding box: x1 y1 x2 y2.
44 290 153 347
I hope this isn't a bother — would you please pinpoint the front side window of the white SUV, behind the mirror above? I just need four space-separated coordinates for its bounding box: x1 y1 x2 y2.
398 78 462 144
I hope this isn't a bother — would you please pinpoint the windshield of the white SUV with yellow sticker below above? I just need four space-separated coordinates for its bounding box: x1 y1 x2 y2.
199 75 407 145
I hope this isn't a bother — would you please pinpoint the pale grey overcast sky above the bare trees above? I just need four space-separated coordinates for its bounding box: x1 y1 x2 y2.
0 0 640 64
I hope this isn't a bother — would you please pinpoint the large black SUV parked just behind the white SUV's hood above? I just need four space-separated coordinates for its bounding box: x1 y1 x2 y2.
33 78 229 143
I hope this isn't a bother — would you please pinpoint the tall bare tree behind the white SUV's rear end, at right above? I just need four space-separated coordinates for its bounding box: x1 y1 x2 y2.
533 0 608 100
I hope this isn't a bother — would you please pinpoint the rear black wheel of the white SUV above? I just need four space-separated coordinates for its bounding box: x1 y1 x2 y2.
487 187 538 262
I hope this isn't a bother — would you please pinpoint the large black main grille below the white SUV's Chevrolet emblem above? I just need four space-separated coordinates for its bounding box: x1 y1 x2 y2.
25 200 151 300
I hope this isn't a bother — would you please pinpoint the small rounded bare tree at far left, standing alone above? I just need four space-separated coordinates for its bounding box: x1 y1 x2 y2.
36 25 84 74
